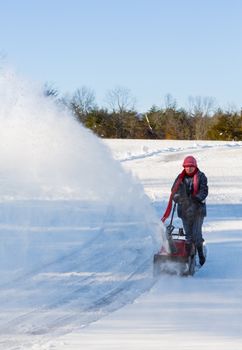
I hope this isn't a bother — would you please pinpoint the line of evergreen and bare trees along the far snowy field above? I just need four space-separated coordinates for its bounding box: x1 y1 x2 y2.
44 87 242 141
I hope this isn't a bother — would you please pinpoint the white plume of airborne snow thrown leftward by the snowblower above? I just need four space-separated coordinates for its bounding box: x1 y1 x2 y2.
0 69 162 241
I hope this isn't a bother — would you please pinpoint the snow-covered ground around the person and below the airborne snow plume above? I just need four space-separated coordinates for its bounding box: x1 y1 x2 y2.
0 140 242 350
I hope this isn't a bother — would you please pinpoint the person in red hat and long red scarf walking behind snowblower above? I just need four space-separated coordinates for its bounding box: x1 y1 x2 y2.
161 156 208 265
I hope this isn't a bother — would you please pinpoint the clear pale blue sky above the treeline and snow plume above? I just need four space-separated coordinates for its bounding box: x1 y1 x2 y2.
0 0 242 112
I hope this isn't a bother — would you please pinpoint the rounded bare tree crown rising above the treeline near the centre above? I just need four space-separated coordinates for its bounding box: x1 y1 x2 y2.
106 86 136 114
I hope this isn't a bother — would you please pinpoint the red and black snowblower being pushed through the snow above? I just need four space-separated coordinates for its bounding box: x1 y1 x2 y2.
153 203 200 276
